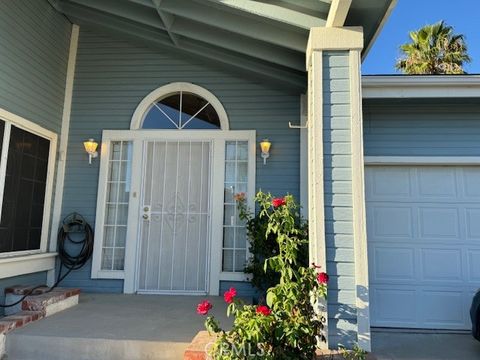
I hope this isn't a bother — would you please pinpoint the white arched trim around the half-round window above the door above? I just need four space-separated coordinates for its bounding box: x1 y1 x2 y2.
130 82 230 130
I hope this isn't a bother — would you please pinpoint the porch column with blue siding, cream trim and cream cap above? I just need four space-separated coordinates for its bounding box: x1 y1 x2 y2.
306 27 370 351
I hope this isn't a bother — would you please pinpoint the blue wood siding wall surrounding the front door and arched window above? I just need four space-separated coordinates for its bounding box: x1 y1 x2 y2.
63 28 300 292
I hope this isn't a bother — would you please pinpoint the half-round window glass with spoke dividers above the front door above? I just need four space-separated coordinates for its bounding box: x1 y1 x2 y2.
142 93 220 129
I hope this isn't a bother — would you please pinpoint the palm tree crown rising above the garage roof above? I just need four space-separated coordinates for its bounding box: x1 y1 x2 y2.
395 21 471 75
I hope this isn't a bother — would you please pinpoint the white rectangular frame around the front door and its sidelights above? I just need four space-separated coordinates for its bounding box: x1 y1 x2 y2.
91 129 256 295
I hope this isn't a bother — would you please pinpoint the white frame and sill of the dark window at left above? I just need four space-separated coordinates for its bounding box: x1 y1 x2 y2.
0 108 57 278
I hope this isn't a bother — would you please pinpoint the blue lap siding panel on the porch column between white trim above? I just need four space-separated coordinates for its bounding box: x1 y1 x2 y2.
323 51 357 348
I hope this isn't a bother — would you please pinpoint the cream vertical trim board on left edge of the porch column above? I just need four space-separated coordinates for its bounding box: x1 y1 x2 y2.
307 50 329 349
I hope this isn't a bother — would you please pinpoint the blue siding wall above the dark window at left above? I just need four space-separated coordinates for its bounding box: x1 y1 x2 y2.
0 0 71 133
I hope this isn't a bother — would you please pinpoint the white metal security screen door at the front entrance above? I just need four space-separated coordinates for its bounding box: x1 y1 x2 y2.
137 140 212 294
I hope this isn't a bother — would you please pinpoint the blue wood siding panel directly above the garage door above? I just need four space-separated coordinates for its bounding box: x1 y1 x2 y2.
363 99 480 156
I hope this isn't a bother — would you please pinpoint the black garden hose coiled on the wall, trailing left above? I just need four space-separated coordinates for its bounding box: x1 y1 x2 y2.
0 213 93 308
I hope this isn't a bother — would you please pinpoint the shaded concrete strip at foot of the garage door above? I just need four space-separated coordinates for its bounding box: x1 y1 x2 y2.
372 329 480 360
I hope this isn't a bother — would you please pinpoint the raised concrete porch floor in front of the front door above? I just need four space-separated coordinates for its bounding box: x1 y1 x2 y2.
6 294 231 360
